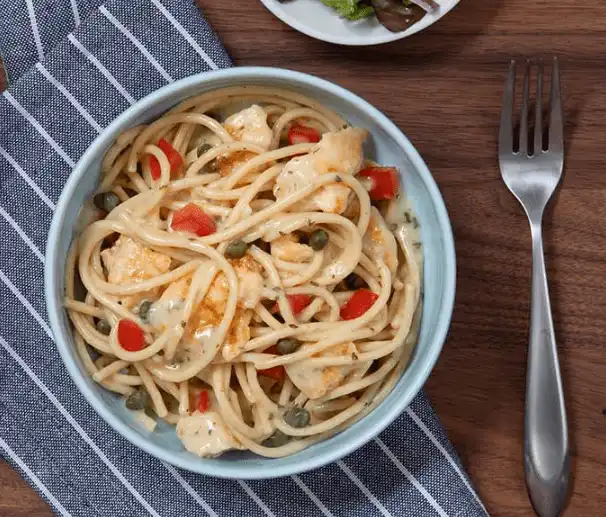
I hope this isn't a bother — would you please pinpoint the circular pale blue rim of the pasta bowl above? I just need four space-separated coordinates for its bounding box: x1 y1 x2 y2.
44 67 456 479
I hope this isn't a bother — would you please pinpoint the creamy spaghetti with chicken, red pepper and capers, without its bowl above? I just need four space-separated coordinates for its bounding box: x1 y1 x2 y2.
65 86 422 457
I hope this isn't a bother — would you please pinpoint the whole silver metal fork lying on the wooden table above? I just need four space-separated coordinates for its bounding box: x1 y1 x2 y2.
499 59 570 517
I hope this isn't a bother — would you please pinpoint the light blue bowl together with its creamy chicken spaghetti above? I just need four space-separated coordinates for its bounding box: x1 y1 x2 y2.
45 67 455 479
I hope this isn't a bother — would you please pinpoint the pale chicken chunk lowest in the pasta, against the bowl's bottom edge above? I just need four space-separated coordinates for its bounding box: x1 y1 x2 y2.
177 411 244 458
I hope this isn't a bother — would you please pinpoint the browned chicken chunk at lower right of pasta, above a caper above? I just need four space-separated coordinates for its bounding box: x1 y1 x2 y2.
284 341 358 399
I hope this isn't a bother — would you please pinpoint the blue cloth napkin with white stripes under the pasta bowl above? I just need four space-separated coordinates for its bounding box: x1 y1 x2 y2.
0 0 486 517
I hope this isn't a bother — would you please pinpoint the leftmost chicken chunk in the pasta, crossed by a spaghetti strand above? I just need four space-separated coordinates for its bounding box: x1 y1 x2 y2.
101 235 171 308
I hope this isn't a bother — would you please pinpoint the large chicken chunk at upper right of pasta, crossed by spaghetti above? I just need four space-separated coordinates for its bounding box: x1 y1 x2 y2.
273 128 367 214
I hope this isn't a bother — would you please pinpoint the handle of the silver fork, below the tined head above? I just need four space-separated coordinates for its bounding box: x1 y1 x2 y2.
524 220 570 517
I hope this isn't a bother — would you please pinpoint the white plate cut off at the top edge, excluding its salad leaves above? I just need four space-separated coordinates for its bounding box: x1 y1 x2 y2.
261 0 459 46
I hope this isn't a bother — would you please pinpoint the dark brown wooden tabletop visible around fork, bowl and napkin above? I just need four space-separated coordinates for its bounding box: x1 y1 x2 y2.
0 0 606 517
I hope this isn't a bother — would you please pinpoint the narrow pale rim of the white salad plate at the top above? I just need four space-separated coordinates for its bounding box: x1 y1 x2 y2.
261 0 461 47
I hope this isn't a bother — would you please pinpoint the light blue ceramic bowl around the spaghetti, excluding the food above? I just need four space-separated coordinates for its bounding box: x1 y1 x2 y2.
45 67 455 479
